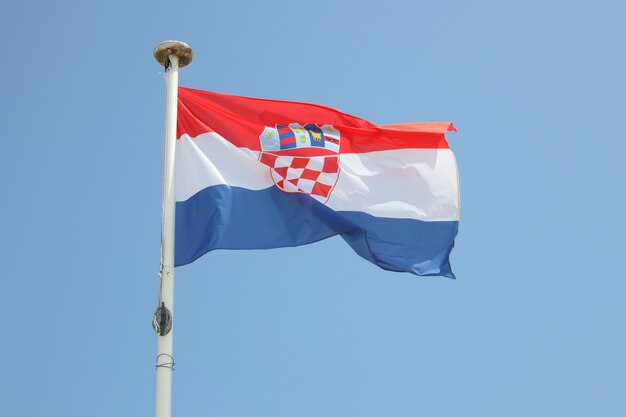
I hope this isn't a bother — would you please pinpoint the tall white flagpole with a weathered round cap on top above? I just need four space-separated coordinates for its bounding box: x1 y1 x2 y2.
152 41 192 417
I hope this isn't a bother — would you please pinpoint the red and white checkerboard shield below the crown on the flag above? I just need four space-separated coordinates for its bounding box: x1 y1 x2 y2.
260 152 339 203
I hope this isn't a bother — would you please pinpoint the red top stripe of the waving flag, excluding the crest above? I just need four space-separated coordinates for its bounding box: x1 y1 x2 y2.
177 87 455 153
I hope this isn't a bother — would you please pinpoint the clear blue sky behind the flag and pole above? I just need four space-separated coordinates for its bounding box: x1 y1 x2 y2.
0 0 626 417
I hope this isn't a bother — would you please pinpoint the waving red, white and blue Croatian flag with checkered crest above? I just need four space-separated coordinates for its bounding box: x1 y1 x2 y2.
175 87 459 278
